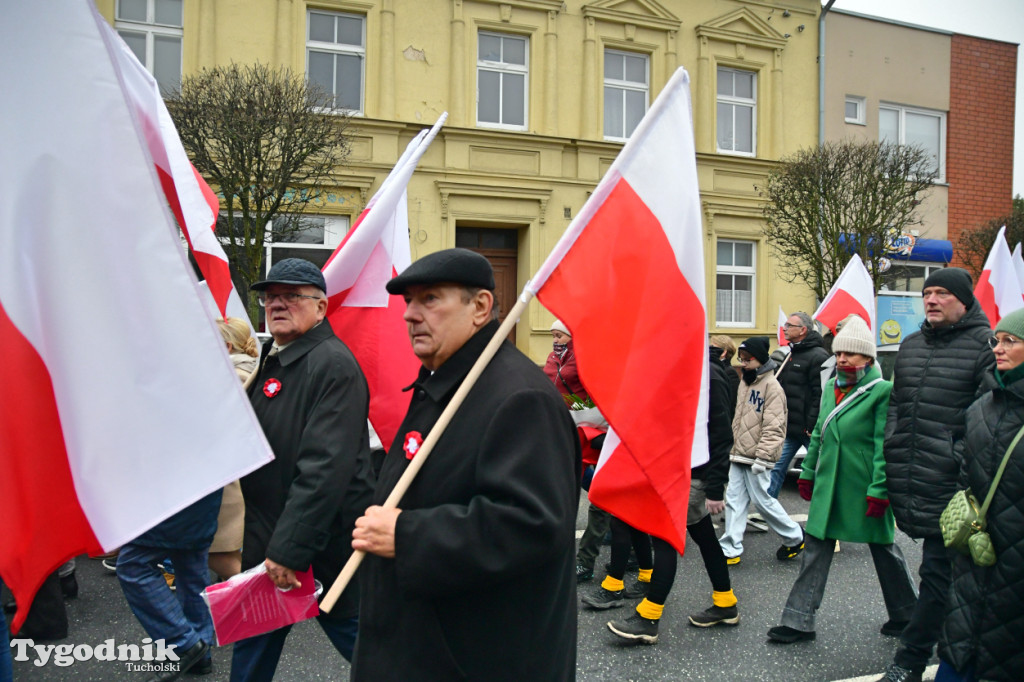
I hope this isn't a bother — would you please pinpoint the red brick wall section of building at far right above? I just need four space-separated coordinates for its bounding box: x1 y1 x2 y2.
946 35 1017 265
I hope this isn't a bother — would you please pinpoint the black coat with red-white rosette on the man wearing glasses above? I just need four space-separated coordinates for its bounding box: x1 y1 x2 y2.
242 322 373 619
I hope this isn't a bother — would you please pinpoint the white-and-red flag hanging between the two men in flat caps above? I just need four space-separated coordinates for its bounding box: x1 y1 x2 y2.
324 113 447 450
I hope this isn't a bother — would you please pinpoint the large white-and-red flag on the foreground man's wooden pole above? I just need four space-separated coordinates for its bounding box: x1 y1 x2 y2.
527 69 708 551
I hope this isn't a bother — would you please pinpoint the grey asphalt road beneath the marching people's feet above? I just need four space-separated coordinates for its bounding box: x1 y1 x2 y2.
8 478 937 682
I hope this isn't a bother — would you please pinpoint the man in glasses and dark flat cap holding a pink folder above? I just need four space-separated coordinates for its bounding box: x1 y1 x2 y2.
231 258 373 681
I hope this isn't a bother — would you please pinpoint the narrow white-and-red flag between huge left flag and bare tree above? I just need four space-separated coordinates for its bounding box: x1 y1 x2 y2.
102 24 235 317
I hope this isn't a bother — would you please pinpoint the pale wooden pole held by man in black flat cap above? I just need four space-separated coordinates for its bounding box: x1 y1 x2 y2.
319 290 534 612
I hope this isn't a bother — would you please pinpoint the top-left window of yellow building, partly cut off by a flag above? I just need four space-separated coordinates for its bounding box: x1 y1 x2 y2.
114 0 184 97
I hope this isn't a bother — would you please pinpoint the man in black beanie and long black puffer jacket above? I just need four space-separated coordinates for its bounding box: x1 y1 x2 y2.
880 267 995 682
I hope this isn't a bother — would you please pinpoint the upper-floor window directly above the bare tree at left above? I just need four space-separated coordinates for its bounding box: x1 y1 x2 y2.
306 9 367 113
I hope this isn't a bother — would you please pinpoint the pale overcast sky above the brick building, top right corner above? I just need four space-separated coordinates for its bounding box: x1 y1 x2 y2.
822 0 1024 196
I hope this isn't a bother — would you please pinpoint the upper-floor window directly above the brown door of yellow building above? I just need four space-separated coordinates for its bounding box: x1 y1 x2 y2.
476 31 529 130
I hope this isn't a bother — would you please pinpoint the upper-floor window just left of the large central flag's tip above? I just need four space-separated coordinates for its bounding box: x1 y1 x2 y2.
604 50 650 140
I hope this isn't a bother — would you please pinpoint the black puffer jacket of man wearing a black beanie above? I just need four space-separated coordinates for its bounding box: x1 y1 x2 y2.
885 301 995 538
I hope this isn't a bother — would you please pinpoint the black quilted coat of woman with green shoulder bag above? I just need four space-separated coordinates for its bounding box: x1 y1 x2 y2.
940 380 1024 682
